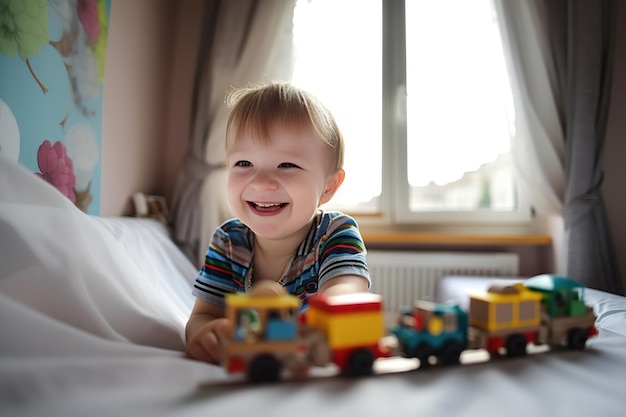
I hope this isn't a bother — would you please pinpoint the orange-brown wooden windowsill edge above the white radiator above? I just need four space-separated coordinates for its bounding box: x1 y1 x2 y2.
362 231 552 247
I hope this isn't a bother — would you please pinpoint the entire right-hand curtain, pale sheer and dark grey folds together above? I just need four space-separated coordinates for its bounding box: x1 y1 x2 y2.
495 0 623 293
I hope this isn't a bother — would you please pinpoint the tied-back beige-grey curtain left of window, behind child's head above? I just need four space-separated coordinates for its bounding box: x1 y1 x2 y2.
171 0 295 264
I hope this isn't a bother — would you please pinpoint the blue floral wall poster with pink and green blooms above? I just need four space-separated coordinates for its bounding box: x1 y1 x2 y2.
0 0 111 214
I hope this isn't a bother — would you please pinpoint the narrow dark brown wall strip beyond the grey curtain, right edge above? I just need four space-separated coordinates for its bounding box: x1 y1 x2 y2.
602 2 626 290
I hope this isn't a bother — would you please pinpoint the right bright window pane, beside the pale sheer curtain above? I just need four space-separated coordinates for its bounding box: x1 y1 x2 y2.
405 0 516 212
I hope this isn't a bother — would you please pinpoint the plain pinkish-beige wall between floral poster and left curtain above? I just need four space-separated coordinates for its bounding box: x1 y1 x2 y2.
101 0 203 216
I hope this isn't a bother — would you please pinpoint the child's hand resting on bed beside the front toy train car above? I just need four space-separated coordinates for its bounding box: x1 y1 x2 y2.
187 318 230 364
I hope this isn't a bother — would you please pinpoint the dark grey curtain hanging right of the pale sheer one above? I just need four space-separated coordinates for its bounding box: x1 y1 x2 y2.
542 0 623 294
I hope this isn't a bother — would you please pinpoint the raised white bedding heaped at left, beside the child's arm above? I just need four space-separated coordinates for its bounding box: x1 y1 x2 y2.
0 153 197 355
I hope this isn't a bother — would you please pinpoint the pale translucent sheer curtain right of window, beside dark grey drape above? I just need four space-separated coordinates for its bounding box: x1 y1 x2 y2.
494 0 566 274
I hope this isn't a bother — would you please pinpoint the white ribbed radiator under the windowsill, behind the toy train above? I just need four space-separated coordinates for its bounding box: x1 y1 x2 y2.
367 250 519 324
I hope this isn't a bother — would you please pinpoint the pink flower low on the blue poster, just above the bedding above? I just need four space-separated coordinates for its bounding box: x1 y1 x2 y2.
36 140 76 203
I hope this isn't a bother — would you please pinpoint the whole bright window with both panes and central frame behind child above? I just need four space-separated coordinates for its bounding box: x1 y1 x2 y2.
292 0 528 229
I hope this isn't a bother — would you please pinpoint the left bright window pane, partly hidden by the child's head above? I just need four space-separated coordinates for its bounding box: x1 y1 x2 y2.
292 0 382 213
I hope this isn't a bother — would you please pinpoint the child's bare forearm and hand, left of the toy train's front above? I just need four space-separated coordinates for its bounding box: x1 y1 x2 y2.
185 299 229 364
